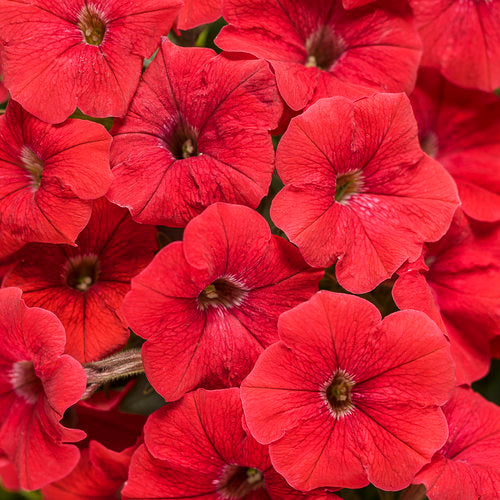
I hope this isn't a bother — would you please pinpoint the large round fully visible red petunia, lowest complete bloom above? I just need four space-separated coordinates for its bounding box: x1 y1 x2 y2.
241 291 455 490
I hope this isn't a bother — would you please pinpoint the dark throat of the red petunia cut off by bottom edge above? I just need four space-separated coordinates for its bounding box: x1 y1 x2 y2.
215 465 264 499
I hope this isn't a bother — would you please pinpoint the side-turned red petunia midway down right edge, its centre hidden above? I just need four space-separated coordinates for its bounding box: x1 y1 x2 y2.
392 211 500 384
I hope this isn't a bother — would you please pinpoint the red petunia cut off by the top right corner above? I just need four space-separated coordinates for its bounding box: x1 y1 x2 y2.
410 0 500 92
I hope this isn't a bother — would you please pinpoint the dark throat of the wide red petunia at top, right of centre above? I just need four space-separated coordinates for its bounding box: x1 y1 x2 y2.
305 26 345 70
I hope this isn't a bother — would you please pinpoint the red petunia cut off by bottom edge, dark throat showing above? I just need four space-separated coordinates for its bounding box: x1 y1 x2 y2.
123 388 338 500
